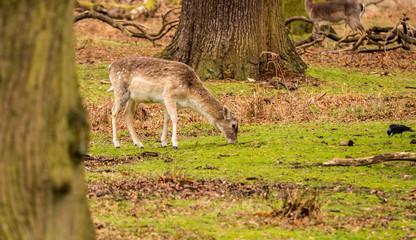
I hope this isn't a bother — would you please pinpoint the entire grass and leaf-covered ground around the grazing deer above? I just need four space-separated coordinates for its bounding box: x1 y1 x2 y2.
74 4 416 239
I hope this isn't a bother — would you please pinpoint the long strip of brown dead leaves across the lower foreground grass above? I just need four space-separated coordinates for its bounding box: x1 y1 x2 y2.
87 173 299 201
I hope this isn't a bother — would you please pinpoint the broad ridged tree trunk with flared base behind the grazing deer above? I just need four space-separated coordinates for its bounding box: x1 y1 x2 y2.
157 0 306 80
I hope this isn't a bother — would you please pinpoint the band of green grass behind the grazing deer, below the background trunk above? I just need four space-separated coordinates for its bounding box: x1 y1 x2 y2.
77 62 416 104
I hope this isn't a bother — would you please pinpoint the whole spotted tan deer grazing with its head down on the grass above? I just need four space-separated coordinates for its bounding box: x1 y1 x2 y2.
108 57 238 148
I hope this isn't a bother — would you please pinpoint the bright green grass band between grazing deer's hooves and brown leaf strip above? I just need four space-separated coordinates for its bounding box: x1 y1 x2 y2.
90 122 416 190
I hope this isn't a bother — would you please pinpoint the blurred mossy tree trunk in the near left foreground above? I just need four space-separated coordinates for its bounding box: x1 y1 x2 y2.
0 0 95 240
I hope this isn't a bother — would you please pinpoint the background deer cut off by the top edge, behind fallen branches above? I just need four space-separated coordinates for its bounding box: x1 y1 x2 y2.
305 0 365 34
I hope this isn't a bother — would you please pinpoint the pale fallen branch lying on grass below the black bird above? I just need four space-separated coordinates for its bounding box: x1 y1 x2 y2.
322 152 416 166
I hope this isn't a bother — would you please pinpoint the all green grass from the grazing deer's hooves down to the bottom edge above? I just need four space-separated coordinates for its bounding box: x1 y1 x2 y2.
87 122 416 239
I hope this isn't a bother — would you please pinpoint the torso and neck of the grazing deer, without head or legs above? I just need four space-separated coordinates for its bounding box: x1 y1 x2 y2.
110 57 222 115
